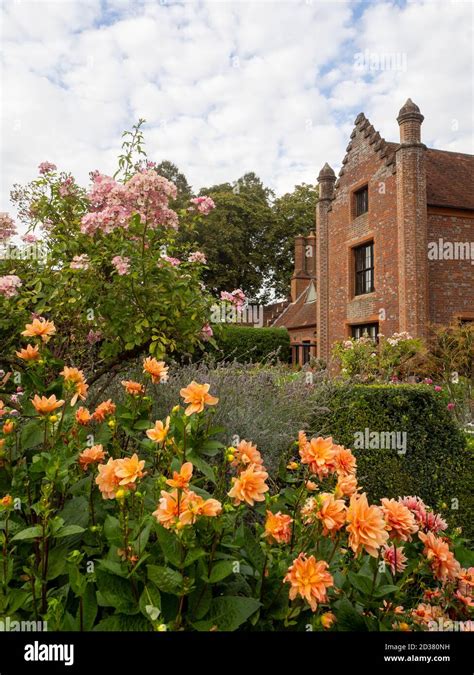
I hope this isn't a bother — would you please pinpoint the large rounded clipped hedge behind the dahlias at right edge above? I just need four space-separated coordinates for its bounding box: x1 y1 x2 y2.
312 385 474 536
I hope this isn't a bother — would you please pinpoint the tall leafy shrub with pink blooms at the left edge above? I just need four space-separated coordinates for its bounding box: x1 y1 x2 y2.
0 123 217 377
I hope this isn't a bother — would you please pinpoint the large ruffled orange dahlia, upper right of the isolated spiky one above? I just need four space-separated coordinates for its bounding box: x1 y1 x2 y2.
347 493 388 557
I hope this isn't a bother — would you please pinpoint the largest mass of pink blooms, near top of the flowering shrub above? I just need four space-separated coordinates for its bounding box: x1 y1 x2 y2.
81 169 178 235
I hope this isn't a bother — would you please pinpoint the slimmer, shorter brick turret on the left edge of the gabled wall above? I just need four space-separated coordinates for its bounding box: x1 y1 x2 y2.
316 162 336 360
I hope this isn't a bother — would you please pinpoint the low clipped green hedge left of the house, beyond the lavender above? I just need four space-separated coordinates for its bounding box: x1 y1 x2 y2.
208 324 290 363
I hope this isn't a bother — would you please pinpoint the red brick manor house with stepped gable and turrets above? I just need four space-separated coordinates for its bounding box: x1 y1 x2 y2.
268 99 474 363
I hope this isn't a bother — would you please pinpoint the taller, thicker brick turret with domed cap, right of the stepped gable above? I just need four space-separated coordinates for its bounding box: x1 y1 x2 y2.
396 98 429 337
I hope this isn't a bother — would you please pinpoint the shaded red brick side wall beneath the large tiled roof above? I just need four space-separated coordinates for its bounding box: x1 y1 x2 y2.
428 208 474 324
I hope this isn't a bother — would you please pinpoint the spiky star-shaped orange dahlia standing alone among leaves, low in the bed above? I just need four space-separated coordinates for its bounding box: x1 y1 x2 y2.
283 553 334 612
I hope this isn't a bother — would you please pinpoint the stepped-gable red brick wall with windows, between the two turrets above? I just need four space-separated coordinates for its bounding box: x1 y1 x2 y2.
321 122 398 358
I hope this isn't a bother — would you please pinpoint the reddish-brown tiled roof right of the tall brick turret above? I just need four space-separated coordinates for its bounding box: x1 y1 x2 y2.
426 149 474 209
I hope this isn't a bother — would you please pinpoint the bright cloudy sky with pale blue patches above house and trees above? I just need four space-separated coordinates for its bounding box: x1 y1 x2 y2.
0 0 474 211
